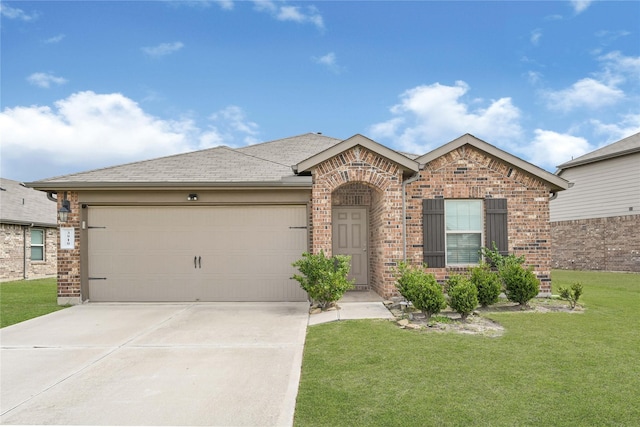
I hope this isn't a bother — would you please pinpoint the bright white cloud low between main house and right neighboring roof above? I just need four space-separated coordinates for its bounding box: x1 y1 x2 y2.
526 129 593 169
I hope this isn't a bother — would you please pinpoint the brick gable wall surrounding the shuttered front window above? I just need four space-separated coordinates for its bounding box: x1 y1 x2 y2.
407 145 551 295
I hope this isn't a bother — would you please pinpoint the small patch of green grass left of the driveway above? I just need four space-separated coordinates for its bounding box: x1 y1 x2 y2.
0 278 65 328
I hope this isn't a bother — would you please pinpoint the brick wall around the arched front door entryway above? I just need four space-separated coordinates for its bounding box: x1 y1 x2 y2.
311 146 402 296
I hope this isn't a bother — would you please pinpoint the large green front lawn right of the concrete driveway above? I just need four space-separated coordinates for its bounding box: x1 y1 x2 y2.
295 271 640 426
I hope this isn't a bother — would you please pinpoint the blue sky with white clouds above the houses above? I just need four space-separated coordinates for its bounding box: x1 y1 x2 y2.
0 0 640 181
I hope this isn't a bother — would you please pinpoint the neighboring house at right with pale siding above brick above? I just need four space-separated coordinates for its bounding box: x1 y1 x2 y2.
551 133 640 272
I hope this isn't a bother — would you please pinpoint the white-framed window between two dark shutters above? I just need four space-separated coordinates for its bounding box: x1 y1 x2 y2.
444 200 483 265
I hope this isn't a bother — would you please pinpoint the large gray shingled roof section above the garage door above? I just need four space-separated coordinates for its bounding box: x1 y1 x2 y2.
29 133 340 188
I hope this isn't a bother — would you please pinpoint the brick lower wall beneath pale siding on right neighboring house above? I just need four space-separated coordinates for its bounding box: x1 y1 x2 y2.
551 215 640 272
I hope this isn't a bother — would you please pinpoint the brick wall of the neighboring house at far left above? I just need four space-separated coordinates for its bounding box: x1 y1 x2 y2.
0 224 57 281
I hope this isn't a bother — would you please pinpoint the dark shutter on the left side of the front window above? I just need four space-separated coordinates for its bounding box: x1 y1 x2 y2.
422 199 446 268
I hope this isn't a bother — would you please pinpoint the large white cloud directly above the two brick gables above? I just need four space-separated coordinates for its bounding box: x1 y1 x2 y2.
369 81 522 154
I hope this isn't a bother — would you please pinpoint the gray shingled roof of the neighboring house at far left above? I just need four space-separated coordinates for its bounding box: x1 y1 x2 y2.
0 178 58 227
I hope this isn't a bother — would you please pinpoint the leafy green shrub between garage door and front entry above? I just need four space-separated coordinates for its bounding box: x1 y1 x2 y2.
292 251 354 310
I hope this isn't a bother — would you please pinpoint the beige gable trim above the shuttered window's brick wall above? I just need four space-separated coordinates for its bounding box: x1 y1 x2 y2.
416 133 569 191
